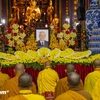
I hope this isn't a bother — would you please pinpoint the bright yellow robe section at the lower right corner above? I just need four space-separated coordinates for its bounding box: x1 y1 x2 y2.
91 79 100 100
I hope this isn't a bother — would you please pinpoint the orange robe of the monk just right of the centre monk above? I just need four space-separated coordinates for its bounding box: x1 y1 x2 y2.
55 77 83 97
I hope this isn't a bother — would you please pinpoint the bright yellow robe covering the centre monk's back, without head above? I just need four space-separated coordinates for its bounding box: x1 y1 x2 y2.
37 68 59 94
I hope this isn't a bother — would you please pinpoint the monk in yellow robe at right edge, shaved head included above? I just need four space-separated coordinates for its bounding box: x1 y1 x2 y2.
84 59 100 94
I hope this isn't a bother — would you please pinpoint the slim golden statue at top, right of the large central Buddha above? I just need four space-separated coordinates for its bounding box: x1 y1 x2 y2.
47 0 54 23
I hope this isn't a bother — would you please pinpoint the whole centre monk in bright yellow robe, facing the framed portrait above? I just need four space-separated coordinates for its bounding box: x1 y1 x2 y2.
37 61 59 100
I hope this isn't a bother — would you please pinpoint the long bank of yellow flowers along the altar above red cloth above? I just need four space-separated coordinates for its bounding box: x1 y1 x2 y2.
0 48 95 69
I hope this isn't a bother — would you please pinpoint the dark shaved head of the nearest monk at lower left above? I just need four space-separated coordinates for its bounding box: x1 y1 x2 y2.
18 72 32 89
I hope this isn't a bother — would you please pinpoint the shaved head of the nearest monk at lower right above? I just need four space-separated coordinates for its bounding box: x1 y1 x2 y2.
68 72 80 87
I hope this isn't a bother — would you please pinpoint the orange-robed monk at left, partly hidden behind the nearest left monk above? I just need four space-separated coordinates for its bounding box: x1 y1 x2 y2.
2 64 36 100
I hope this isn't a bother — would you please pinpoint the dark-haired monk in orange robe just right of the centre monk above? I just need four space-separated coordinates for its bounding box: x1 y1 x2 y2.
55 64 83 97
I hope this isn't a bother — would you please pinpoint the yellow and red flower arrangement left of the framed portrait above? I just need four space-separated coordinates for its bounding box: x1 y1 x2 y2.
6 21 26 47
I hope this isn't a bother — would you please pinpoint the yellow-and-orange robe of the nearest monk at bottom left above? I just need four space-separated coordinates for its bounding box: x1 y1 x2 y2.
8 90 45 100
